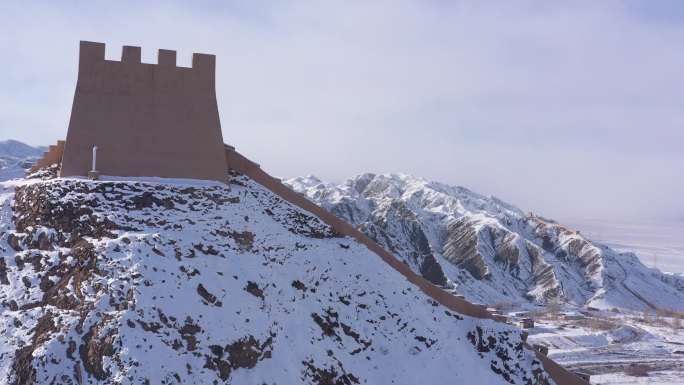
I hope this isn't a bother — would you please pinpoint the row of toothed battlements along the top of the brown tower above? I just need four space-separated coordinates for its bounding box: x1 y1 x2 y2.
79 41 216 74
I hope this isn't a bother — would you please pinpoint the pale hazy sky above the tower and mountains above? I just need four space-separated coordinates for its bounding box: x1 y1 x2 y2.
0 0 684 220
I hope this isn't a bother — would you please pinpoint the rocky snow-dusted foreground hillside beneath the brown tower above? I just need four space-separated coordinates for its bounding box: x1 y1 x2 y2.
0 174 553 385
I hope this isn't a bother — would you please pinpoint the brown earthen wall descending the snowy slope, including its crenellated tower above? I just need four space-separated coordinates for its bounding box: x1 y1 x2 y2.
29 42 589 385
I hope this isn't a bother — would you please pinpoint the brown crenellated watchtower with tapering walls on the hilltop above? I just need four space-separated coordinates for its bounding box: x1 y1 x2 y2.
60 41 227 181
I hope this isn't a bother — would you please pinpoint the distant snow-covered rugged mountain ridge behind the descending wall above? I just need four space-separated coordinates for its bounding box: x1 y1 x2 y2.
286 174 684 310
